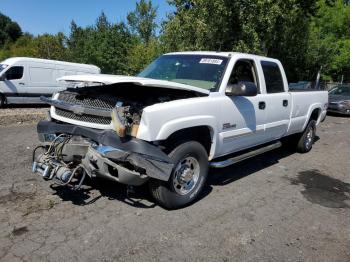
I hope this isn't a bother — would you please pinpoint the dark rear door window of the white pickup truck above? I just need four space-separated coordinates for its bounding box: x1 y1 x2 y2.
261 61 284 94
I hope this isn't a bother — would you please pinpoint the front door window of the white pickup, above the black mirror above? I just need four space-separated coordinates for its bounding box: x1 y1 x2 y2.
229 60 258 87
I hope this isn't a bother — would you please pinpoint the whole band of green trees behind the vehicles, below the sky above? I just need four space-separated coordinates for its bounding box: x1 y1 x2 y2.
0 0 350 82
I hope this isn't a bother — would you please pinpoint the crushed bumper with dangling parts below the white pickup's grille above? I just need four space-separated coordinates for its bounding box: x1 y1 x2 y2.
33 121 173 187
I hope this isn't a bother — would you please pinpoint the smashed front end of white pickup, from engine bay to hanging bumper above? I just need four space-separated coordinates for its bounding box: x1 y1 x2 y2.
33 80 205 189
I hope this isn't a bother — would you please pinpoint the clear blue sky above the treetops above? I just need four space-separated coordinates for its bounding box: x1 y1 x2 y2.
0 0 173 35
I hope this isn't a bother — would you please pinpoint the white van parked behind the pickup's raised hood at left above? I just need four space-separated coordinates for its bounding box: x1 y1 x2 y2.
0 57 101 107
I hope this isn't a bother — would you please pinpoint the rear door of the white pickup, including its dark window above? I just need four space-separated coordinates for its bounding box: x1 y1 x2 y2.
259 60 292 140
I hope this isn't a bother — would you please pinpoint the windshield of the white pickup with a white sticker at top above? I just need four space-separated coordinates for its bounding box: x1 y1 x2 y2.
138 55 228 91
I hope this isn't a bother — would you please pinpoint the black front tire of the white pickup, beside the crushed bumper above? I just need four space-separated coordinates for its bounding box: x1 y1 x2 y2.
149 141 208 209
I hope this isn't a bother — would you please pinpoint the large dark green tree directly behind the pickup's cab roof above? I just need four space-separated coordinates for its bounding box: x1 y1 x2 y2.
161 0 317 80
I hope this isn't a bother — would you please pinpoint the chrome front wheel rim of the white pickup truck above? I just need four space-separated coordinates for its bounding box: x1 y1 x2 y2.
173 156 200 195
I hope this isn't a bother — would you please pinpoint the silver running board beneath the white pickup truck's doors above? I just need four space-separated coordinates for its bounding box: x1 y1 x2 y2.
210 141 282 168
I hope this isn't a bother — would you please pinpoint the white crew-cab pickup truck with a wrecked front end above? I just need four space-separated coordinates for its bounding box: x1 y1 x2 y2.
33 52 328 209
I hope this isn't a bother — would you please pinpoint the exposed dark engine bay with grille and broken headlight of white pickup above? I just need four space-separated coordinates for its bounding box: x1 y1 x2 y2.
50 83 205 137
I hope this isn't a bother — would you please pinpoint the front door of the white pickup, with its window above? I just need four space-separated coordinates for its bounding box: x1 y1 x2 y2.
219 59 267 155
